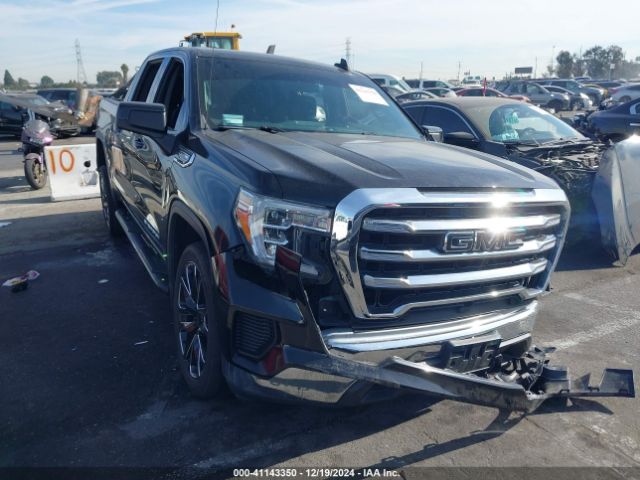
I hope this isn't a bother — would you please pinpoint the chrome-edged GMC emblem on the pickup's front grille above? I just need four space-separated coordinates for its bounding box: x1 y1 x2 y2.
442 230 524 253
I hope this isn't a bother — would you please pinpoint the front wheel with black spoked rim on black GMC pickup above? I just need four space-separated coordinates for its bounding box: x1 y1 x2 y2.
171 242 224 398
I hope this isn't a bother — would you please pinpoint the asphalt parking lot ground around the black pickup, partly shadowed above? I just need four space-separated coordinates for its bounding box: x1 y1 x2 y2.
0 141 640 478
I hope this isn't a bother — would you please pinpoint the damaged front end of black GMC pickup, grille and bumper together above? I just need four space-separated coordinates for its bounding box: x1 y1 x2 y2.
222 188 635 411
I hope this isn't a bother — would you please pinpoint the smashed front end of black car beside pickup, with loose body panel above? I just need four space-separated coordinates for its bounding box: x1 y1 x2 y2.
508 137 640 265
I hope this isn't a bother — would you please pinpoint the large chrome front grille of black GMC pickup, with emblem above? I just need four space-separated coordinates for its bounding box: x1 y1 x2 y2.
332 189 569 319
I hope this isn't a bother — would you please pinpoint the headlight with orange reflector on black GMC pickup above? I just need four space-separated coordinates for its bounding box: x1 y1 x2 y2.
234 189 331 266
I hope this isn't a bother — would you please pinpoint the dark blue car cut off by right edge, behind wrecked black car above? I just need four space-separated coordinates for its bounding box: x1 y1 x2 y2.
586 98 640 142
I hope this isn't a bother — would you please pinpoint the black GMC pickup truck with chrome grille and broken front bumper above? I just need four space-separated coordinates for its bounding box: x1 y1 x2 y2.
97 48 634 410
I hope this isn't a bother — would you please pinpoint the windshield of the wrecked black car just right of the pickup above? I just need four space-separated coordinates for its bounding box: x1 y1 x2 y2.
465 103 585 144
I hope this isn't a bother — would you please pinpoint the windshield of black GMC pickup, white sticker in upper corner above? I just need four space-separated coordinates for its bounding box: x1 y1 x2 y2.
198 57 421 139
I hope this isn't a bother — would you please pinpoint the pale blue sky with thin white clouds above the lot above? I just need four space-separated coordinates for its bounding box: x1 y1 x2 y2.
0 0 640 82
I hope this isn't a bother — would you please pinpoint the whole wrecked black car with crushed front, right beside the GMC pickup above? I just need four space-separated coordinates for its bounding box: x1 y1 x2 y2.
403 97 640 264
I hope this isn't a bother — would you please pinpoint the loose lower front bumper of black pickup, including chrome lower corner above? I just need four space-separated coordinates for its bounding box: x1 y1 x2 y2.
228 346 635 412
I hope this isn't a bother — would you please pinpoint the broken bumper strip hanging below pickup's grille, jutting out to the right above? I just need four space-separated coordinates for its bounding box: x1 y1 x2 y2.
283 346 635 412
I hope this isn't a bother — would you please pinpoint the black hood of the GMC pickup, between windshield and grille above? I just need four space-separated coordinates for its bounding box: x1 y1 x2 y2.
206 130 557 207
